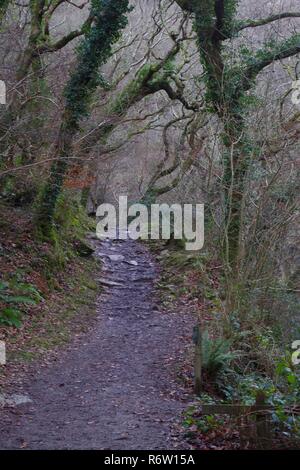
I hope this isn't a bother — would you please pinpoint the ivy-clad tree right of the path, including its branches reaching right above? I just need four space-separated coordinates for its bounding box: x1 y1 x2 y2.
176 0 300 273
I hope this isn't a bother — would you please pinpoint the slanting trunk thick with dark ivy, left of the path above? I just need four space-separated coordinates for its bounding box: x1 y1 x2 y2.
36 0 129 237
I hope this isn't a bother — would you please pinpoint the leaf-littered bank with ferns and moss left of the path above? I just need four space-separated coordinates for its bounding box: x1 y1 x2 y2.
0 191 96 358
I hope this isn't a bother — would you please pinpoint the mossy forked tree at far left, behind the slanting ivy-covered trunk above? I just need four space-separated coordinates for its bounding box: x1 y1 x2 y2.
0 0 93 173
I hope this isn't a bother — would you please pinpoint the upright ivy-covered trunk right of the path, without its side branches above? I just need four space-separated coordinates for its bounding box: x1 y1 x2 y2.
193 0 245 272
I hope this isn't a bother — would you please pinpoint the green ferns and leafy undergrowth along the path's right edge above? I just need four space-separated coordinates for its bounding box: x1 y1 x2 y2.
154 241 300 446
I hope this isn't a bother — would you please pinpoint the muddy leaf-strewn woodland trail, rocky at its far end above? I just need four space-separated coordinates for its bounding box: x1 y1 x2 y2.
0 241 190 450
